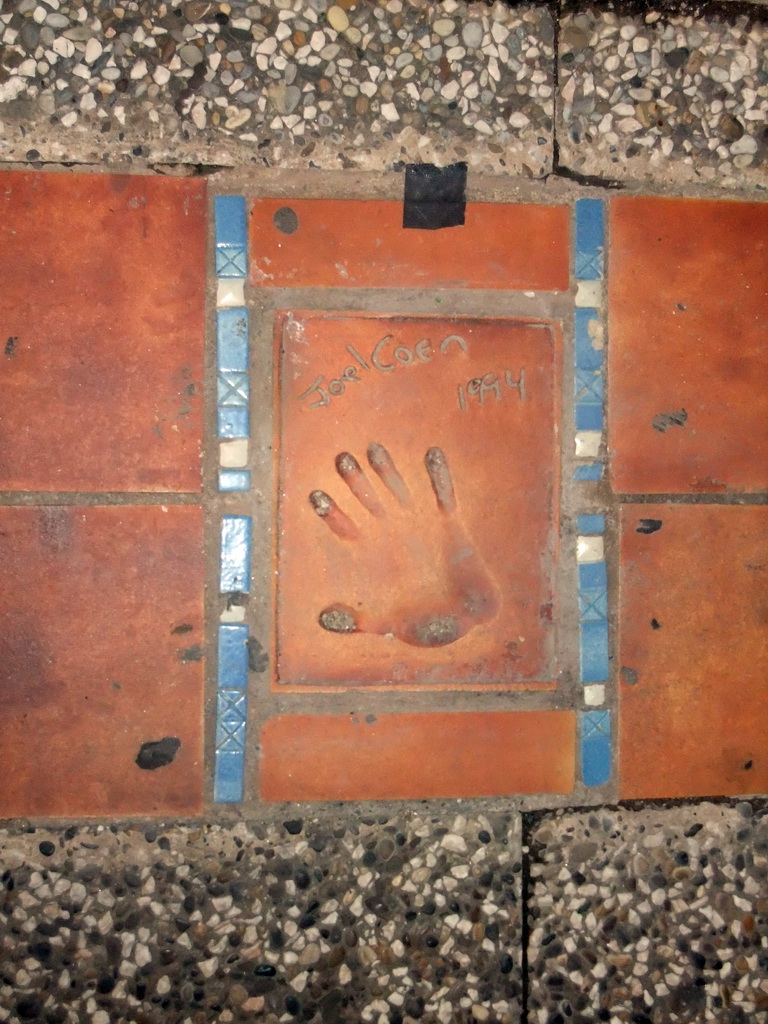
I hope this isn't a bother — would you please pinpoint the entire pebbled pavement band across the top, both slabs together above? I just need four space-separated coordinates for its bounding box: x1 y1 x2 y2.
0 0 768 188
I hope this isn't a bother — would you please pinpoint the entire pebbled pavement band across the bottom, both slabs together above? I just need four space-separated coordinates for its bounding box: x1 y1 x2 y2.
0 801 768 1024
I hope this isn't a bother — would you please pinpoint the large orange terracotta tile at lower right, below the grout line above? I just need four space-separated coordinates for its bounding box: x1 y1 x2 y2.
620 505 768 799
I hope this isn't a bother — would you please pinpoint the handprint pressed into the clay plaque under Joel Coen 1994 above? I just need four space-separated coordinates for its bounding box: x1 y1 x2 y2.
309 444 500 647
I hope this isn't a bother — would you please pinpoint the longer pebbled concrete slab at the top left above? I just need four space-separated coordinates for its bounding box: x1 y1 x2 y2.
0 0 554 178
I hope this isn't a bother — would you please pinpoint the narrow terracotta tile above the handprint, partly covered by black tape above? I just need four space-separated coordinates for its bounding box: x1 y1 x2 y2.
250 199 570 291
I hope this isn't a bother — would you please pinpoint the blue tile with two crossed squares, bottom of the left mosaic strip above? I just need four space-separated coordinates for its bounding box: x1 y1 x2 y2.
213 623 248 803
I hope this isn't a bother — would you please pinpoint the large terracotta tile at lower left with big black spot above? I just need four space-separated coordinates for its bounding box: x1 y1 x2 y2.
0 506 203 817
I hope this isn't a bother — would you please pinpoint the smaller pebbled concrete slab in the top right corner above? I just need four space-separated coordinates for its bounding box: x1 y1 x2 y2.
556 4 768 187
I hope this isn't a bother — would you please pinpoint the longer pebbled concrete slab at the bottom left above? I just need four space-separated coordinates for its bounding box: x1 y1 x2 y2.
0 805 522 1024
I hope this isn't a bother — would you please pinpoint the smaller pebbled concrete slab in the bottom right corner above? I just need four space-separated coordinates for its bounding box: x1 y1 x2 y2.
527 802 768 1024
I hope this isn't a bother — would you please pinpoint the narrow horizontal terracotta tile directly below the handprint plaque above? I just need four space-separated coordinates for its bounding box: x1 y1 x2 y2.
260 711 575 801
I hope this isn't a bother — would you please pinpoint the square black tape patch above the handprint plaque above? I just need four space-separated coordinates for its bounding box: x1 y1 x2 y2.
402 163 467 231
